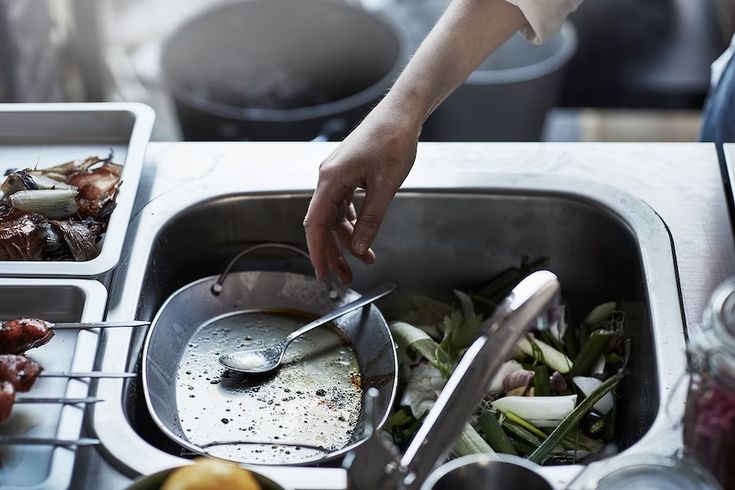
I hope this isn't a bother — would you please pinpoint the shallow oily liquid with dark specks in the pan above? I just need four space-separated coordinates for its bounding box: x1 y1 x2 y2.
176 312 361 464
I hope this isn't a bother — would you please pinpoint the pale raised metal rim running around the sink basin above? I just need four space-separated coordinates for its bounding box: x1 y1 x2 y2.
92 174 686 489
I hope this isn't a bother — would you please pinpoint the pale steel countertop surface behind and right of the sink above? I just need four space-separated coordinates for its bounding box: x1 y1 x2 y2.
74 143 735 489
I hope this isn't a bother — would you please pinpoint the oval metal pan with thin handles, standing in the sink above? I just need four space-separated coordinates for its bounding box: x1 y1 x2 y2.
142 244 398 464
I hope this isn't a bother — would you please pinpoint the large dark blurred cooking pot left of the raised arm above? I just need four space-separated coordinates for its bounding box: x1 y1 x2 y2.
161 0 403 140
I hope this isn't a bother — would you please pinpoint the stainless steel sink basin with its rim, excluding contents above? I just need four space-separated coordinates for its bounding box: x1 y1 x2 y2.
93 175 686 488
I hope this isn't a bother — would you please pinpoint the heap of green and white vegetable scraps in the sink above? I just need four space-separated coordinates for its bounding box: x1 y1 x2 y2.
384 259 630 464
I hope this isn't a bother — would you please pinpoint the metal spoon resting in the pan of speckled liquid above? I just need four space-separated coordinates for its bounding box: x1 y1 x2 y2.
219 283 396 374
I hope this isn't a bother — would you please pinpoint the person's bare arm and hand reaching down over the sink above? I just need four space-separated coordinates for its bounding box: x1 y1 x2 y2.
304 0 526 284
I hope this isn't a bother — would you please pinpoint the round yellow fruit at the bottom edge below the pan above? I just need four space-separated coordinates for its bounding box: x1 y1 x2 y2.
161 458 261 490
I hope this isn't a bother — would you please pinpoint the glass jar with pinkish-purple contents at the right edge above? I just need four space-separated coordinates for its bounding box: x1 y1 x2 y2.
684 278 735 490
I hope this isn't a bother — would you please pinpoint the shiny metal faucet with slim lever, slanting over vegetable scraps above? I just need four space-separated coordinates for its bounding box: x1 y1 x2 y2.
344 271 561 490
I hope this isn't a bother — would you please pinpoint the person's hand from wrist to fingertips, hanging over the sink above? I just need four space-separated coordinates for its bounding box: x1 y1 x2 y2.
304 104 420 285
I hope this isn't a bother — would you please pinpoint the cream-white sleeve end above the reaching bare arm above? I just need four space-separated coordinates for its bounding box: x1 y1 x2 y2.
506 0 582 44
